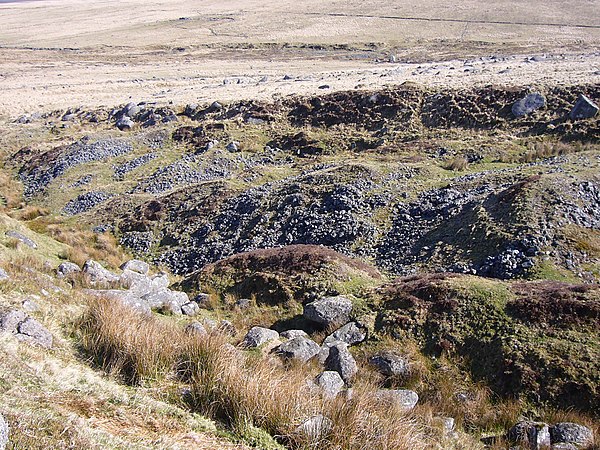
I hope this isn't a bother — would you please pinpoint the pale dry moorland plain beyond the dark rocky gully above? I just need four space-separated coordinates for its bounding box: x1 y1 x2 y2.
0 0 600 118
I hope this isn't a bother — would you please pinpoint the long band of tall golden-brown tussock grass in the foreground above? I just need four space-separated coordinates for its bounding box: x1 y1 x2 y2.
80 300 425 449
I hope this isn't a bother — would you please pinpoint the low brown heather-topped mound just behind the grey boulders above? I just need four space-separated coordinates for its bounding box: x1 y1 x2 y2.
182 245 382 304
